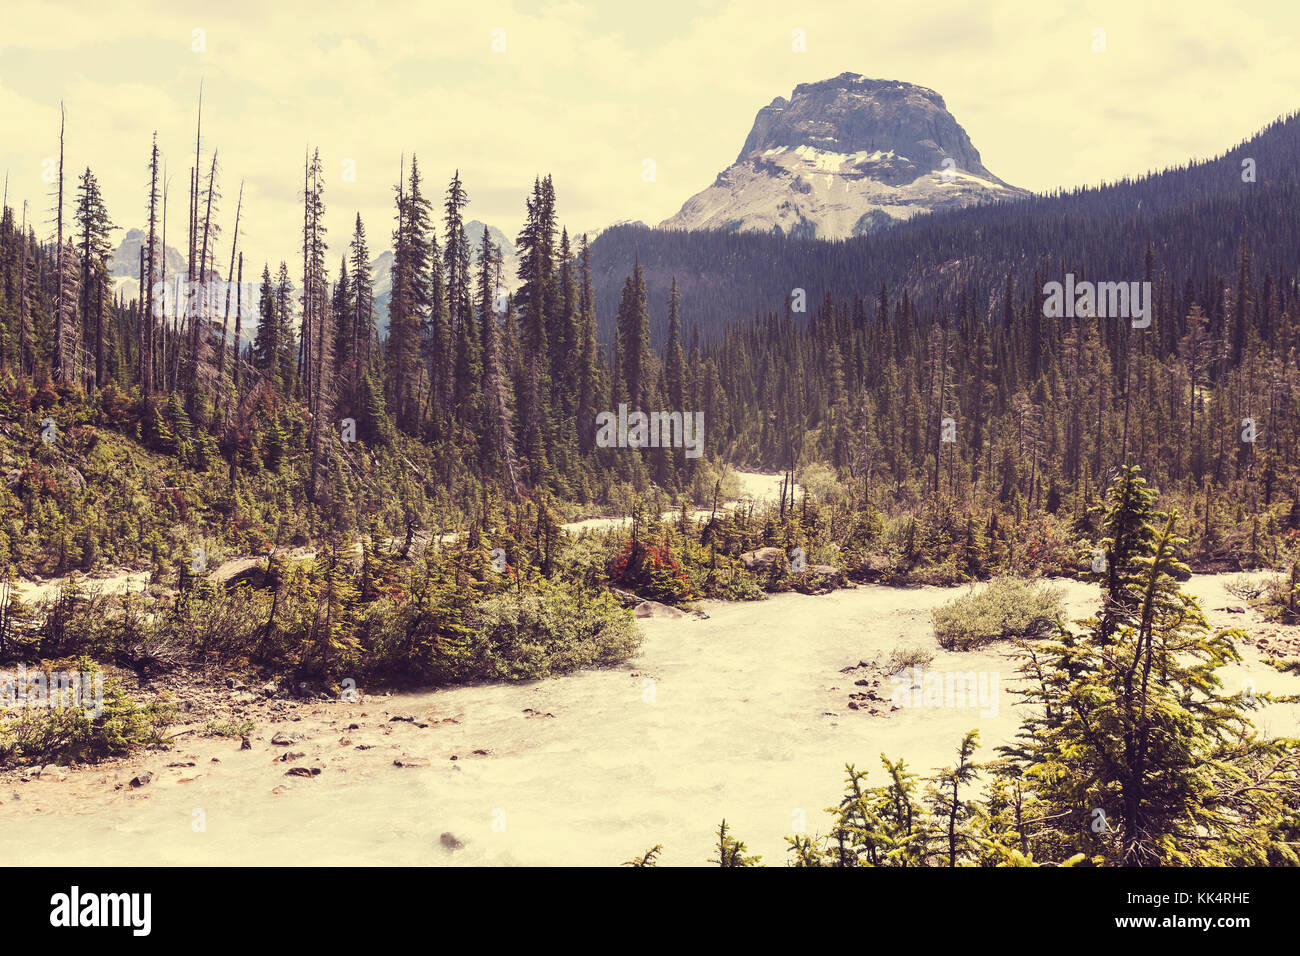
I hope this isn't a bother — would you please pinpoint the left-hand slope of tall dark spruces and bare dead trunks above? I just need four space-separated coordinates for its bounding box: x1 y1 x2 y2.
0 123 733 582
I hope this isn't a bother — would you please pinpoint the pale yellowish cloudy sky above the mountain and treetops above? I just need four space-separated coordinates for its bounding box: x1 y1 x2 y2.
0 0 1300 277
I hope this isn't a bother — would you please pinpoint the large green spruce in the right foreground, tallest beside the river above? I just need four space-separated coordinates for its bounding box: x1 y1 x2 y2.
1001 466 1295 866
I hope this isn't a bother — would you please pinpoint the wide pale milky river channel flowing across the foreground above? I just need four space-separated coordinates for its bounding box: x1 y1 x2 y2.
0 478 1300 865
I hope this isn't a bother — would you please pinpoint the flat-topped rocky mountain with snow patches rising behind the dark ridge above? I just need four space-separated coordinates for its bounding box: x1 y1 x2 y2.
659 73 1028 239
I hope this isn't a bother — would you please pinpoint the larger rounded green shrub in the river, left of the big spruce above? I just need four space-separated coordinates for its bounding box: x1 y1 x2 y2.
935 578 1062 650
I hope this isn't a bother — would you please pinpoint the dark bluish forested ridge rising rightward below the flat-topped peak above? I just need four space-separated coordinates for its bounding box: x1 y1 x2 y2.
592 114 1300 345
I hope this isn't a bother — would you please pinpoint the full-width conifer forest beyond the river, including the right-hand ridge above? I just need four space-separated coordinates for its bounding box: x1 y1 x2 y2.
0 100 1300 590
